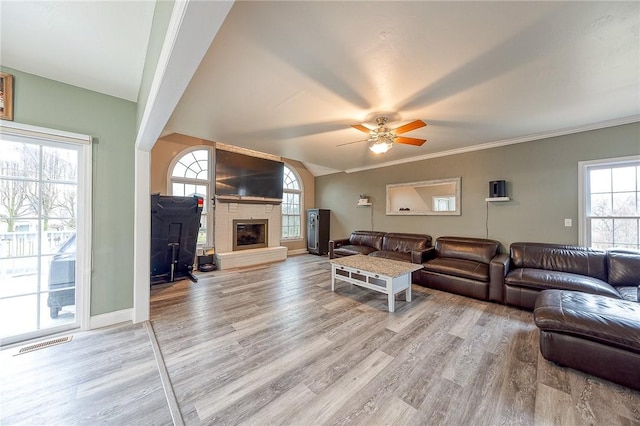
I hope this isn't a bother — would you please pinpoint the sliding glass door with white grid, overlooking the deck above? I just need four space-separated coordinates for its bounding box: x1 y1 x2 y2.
0 128 87 344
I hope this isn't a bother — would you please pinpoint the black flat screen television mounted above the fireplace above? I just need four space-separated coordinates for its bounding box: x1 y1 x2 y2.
216 149 284 200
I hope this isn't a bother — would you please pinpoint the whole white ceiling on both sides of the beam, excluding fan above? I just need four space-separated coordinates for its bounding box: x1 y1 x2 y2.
1 1 640 174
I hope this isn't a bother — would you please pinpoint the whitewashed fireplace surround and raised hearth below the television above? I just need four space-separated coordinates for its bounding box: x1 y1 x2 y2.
214 200 287 269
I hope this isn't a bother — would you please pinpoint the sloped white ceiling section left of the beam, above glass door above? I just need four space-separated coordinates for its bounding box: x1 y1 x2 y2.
0 0 155 102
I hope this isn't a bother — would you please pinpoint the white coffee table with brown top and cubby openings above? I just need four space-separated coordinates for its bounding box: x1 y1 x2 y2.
329 254 422 312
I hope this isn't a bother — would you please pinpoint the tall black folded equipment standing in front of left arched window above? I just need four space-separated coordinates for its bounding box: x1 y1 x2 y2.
151 194 204 284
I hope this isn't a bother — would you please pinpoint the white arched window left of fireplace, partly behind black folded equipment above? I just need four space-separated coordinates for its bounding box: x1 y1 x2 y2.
169 146 212 247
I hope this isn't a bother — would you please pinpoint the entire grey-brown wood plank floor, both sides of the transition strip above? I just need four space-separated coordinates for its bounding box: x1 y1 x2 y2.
0 255 640 425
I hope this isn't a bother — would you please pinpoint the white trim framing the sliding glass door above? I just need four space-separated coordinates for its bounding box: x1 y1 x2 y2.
0 121 93 334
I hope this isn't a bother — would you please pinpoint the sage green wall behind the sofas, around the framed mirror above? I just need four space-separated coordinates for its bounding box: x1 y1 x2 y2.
316 123 640 250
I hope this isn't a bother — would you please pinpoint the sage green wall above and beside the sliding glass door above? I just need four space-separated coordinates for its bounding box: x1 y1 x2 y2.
2 68 136 316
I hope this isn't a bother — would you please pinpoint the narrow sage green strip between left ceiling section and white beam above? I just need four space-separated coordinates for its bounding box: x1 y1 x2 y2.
136 0 175 129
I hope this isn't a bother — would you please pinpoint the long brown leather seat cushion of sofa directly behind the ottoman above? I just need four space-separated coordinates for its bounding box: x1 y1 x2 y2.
504 268 621 299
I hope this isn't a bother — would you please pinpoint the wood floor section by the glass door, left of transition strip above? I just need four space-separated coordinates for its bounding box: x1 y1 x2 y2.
0 324 171 425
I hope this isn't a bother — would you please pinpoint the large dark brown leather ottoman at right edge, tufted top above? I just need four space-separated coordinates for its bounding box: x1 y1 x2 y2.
533 290 640 390
